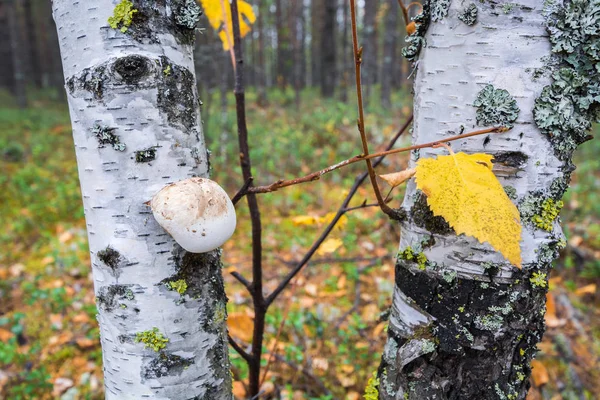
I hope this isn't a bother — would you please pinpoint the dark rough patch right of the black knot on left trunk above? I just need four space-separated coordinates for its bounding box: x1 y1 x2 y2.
158 57 199 133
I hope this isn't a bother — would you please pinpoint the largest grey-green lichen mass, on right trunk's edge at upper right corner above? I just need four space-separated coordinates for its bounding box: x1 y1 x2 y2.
533 0 600 161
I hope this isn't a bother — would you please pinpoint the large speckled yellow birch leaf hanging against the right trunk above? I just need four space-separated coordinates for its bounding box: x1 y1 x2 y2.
416 152 521 268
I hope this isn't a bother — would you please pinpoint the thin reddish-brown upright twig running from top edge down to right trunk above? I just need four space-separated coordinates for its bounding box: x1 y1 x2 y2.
350 0 397 219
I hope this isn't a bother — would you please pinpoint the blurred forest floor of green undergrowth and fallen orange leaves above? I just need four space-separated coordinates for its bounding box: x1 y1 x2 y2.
0 91 600 400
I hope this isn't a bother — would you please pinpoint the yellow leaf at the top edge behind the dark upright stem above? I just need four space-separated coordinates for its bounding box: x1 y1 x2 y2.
200 0 256 51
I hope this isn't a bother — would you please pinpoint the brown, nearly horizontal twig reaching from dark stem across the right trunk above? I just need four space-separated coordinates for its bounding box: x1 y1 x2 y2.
241 123 507 193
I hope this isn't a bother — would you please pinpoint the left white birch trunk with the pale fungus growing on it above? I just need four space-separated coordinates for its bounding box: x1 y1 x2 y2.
53 0 232 400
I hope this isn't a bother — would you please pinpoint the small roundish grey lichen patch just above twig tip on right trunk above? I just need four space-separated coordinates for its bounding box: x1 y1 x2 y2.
473 85 520 128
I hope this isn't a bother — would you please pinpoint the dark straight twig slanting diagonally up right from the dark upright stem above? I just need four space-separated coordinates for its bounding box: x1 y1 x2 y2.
265 115 413 307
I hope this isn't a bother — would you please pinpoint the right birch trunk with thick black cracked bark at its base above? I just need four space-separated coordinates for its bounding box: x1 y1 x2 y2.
378 0 597 400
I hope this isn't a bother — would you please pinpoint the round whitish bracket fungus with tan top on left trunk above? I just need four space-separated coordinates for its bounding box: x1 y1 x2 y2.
150 178 236 253
